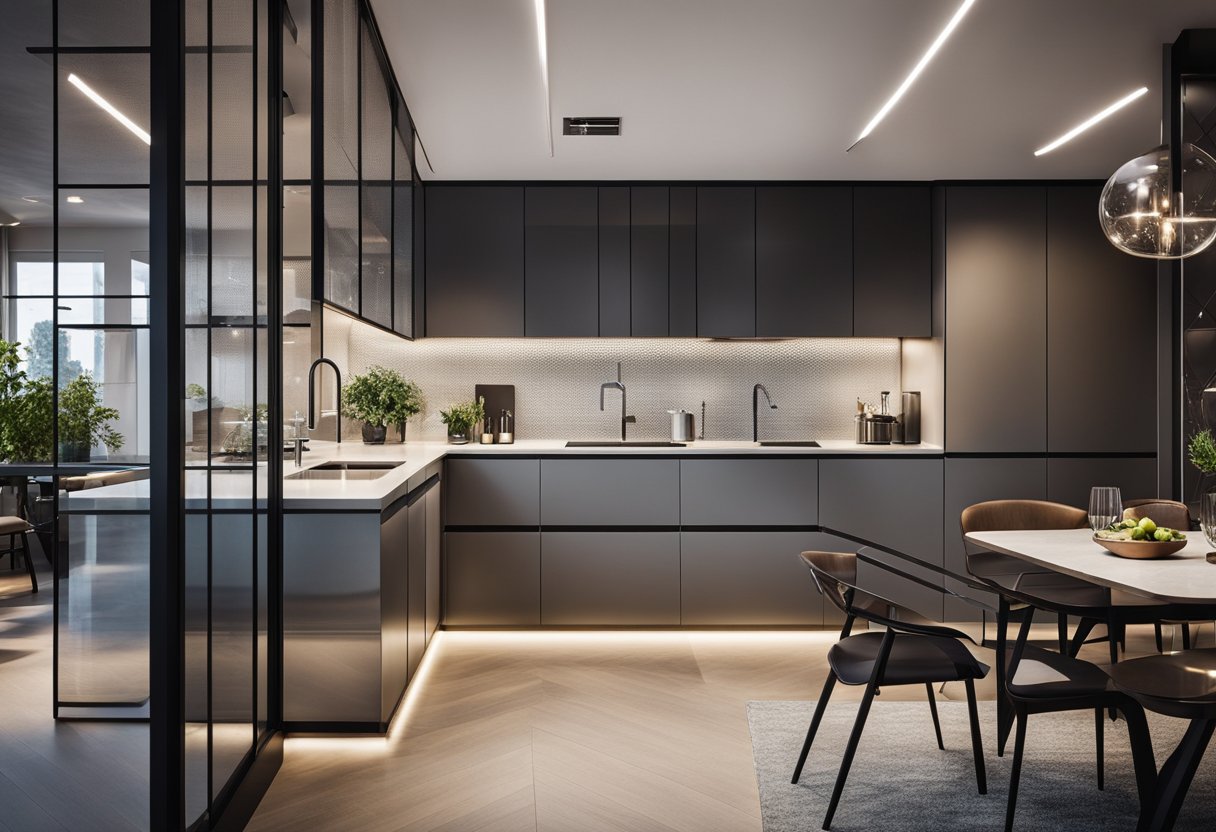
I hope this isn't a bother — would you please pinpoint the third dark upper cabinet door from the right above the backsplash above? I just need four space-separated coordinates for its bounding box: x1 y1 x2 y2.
697 185 756 338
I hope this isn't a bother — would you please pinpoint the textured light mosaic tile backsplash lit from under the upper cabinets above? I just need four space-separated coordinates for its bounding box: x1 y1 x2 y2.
325 315 900 440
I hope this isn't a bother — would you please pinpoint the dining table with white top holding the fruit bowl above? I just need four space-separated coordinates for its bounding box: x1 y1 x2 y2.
966 529 1216 832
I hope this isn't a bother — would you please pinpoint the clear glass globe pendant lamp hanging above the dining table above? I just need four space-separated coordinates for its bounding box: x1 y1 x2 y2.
1098 144 1216 260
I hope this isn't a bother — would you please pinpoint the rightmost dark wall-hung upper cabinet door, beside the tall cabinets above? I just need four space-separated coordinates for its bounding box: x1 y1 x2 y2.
852 185 933 338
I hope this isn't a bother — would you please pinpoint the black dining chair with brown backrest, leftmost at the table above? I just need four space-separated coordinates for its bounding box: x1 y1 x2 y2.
792 552 989 830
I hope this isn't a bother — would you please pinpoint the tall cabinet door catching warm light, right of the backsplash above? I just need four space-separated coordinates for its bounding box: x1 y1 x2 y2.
946 185 1050 452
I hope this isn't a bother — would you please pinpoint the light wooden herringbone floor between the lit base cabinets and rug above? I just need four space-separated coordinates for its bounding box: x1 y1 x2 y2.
249 628 1177 832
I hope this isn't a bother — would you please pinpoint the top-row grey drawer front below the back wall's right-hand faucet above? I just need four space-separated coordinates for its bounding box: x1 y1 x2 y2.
680 459 820 525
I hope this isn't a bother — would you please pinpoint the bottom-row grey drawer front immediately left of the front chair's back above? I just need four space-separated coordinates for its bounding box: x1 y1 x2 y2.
680 532 831 626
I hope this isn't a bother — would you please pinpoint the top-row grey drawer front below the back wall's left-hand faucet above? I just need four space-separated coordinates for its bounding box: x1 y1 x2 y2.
540 457 680 527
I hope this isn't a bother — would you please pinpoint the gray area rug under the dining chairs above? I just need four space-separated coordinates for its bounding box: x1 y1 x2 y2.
748 699 1216 832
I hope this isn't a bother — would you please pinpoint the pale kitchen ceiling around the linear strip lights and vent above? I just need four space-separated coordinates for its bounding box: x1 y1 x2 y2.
372 0 1216 180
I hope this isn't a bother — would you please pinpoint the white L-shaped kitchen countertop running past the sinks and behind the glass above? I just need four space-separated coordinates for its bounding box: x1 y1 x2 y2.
61 439 941 512
